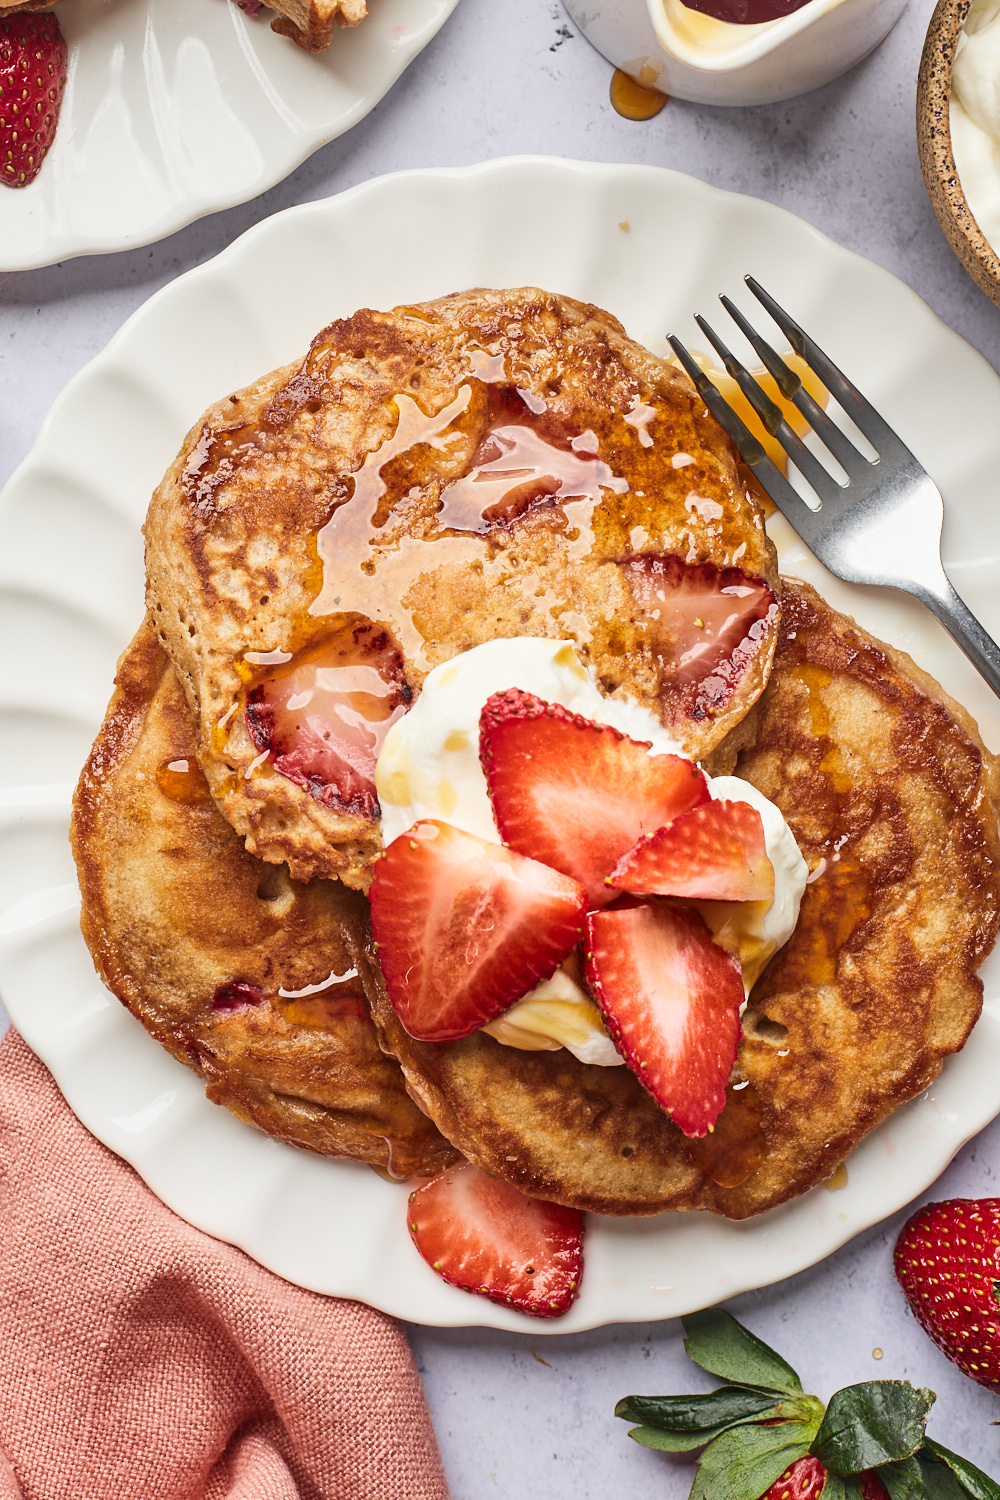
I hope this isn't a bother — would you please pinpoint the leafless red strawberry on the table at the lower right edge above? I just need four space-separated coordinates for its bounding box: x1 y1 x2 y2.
895 1199 1000 1391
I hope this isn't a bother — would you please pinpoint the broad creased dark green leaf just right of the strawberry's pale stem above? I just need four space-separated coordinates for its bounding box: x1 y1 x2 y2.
810 1380 936 1475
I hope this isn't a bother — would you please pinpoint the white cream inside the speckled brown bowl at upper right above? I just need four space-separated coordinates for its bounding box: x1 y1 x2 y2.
949 0 1000 254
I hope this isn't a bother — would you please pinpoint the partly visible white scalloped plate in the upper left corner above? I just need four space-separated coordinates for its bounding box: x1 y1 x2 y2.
0 0 457 272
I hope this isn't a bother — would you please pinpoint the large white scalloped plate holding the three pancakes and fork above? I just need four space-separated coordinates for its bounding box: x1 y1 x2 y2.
0 159 1000 1334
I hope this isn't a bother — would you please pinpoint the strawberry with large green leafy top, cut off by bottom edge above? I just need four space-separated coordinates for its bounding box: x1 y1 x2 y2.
615 1308 1000 1500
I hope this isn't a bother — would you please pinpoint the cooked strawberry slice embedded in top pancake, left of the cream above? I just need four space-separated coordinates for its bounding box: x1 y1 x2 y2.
246 615 412 818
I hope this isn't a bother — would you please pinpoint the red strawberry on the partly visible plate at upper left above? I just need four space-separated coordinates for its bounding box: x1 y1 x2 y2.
0 11 66 188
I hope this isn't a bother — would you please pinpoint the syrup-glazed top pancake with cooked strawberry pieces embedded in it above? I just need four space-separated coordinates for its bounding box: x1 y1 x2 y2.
145 288 780 890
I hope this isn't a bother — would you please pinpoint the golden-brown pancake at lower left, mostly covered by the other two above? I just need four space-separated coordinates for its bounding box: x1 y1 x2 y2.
72 626 456 1178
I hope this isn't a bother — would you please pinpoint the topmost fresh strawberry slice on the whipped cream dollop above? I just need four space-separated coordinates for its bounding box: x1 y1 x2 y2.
480 687 709 906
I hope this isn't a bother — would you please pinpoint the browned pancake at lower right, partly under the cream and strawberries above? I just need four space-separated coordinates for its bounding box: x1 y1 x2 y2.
373 579 1000 1220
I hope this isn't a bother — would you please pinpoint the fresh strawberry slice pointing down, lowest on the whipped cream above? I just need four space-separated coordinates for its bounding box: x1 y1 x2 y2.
586 905 744 1136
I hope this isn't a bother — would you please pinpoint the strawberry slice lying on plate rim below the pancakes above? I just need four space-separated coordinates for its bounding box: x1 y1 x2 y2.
408 1161 583 1317
